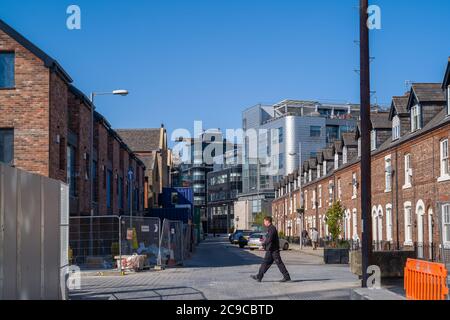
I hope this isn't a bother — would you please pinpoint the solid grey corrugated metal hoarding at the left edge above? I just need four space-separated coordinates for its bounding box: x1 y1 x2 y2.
0 164 68 299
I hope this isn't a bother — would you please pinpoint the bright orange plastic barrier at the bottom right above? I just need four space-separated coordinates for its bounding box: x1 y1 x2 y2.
405 259 448 300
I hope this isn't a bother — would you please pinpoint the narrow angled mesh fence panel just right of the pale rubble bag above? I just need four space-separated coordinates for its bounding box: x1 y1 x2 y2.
158 219 185 267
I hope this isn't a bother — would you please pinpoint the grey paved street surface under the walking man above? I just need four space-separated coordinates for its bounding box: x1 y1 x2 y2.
71 238 360 300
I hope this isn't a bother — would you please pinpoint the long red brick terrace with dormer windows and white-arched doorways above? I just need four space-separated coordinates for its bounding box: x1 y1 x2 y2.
273 60 450 259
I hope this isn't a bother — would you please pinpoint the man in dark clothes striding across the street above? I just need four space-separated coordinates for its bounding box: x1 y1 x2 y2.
252 217 291 282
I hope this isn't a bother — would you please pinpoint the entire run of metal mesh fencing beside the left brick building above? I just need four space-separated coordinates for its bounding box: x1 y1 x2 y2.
69 216 195 271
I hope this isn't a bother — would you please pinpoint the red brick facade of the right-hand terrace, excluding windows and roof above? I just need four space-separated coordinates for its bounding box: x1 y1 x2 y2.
273 123 450 246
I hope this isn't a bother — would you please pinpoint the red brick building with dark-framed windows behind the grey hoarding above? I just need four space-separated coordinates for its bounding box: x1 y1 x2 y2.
0 20 145 215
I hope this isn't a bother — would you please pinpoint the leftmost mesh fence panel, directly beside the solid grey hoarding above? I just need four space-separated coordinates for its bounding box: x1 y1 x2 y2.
69 216 121 269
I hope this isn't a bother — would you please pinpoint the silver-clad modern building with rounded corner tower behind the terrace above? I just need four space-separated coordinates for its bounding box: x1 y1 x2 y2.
235 100 359 228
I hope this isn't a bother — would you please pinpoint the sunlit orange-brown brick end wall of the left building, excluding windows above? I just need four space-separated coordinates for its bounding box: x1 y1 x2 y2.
0 30 50 176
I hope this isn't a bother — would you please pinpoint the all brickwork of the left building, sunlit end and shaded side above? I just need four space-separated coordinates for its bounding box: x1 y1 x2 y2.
0 24 144 215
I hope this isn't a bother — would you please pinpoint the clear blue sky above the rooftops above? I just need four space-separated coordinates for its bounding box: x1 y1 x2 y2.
0 0 450 142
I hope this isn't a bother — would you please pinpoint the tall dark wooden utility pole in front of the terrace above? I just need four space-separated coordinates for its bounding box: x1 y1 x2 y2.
359 0 372 288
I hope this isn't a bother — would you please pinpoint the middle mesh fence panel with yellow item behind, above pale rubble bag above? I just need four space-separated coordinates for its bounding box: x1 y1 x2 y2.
121 216 161 267
